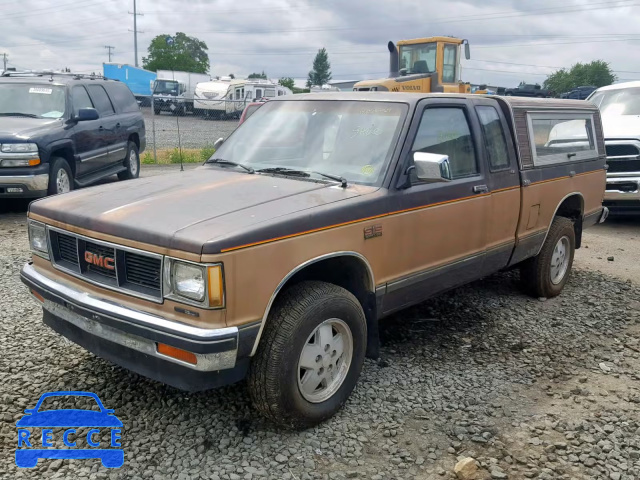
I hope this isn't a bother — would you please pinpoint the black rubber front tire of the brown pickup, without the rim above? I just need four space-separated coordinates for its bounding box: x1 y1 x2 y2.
248 281 367 428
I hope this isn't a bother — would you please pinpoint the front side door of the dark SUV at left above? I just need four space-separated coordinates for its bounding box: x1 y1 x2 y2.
71 85 109 177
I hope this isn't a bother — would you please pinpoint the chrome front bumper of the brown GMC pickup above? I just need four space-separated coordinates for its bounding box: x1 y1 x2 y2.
21 264 239 374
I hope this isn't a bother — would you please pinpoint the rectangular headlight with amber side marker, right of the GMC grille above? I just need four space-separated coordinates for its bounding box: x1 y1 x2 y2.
164 257 224 308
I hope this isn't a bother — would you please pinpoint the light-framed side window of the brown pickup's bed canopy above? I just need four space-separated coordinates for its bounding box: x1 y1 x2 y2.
528 113 598 166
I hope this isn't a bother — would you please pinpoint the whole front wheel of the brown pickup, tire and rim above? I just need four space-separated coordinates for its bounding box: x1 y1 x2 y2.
248 281 367 428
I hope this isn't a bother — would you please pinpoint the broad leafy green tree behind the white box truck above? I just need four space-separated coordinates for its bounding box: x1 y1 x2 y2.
142 32 209 73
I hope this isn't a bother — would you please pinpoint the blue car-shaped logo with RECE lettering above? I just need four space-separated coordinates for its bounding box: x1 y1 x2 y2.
16 391 124 468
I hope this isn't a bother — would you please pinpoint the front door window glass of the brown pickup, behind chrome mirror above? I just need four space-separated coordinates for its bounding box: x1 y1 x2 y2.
411 107 478 181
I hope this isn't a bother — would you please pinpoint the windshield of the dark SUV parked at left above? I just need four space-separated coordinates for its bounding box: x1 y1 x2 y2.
0 83 65 118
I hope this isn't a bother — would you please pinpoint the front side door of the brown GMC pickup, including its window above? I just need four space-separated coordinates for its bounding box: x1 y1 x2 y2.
383 99 491 313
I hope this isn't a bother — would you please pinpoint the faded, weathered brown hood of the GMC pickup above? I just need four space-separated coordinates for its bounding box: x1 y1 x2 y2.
30 166 376 254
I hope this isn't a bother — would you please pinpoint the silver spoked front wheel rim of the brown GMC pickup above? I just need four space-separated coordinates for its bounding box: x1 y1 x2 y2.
298 318 353 403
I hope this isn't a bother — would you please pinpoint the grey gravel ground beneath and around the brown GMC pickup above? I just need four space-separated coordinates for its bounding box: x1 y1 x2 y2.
0 174 640 480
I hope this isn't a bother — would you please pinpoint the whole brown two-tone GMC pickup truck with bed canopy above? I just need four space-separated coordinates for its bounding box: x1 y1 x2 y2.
22 92 608 427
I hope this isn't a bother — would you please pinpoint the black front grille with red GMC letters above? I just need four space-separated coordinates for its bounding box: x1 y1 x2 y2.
48 227 163 302
